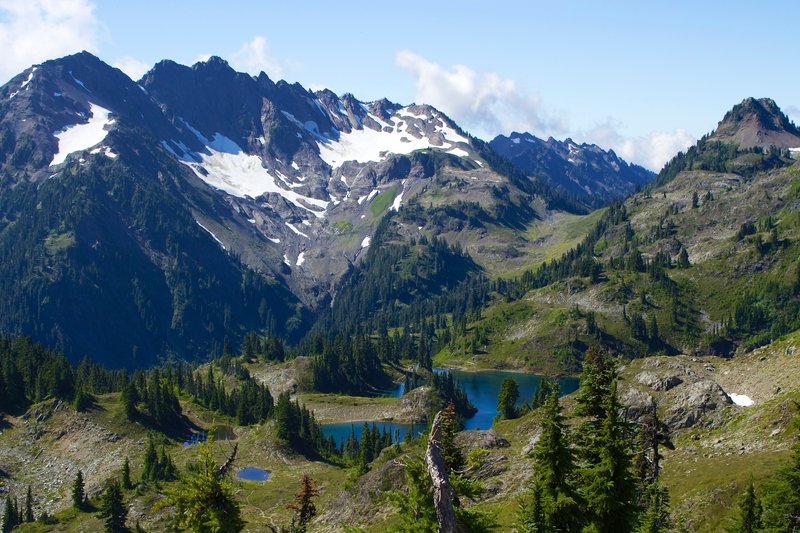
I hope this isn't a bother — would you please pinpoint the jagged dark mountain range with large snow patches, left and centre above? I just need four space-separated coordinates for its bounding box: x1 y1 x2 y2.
0 52 664 366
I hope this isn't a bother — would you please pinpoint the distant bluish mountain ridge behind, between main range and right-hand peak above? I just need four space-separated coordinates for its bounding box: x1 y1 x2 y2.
490 132 655 207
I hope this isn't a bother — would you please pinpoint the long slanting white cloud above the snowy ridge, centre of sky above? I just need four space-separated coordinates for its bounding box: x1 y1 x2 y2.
395 50 566 137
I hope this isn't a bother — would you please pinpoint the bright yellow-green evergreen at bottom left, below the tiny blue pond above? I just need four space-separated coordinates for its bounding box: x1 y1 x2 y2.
156 433 244 533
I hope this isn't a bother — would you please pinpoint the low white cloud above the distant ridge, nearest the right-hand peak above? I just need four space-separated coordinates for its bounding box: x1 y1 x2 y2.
576 120 697 172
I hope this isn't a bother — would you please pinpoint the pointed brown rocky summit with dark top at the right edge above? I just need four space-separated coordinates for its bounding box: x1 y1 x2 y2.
710 97 800 148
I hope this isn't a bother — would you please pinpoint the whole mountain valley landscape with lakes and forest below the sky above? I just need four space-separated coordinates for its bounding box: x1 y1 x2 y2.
0 45 800 533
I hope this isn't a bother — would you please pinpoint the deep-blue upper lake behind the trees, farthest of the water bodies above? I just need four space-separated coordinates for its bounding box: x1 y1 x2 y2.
433 368 579 429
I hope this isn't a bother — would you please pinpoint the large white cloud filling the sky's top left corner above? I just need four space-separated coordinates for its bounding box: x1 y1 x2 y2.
0 0 106 80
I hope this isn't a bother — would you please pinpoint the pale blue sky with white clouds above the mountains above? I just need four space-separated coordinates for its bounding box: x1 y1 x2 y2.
0 0 800 171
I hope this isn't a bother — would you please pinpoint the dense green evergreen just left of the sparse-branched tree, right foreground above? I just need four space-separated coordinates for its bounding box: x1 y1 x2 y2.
584 383 637 533
